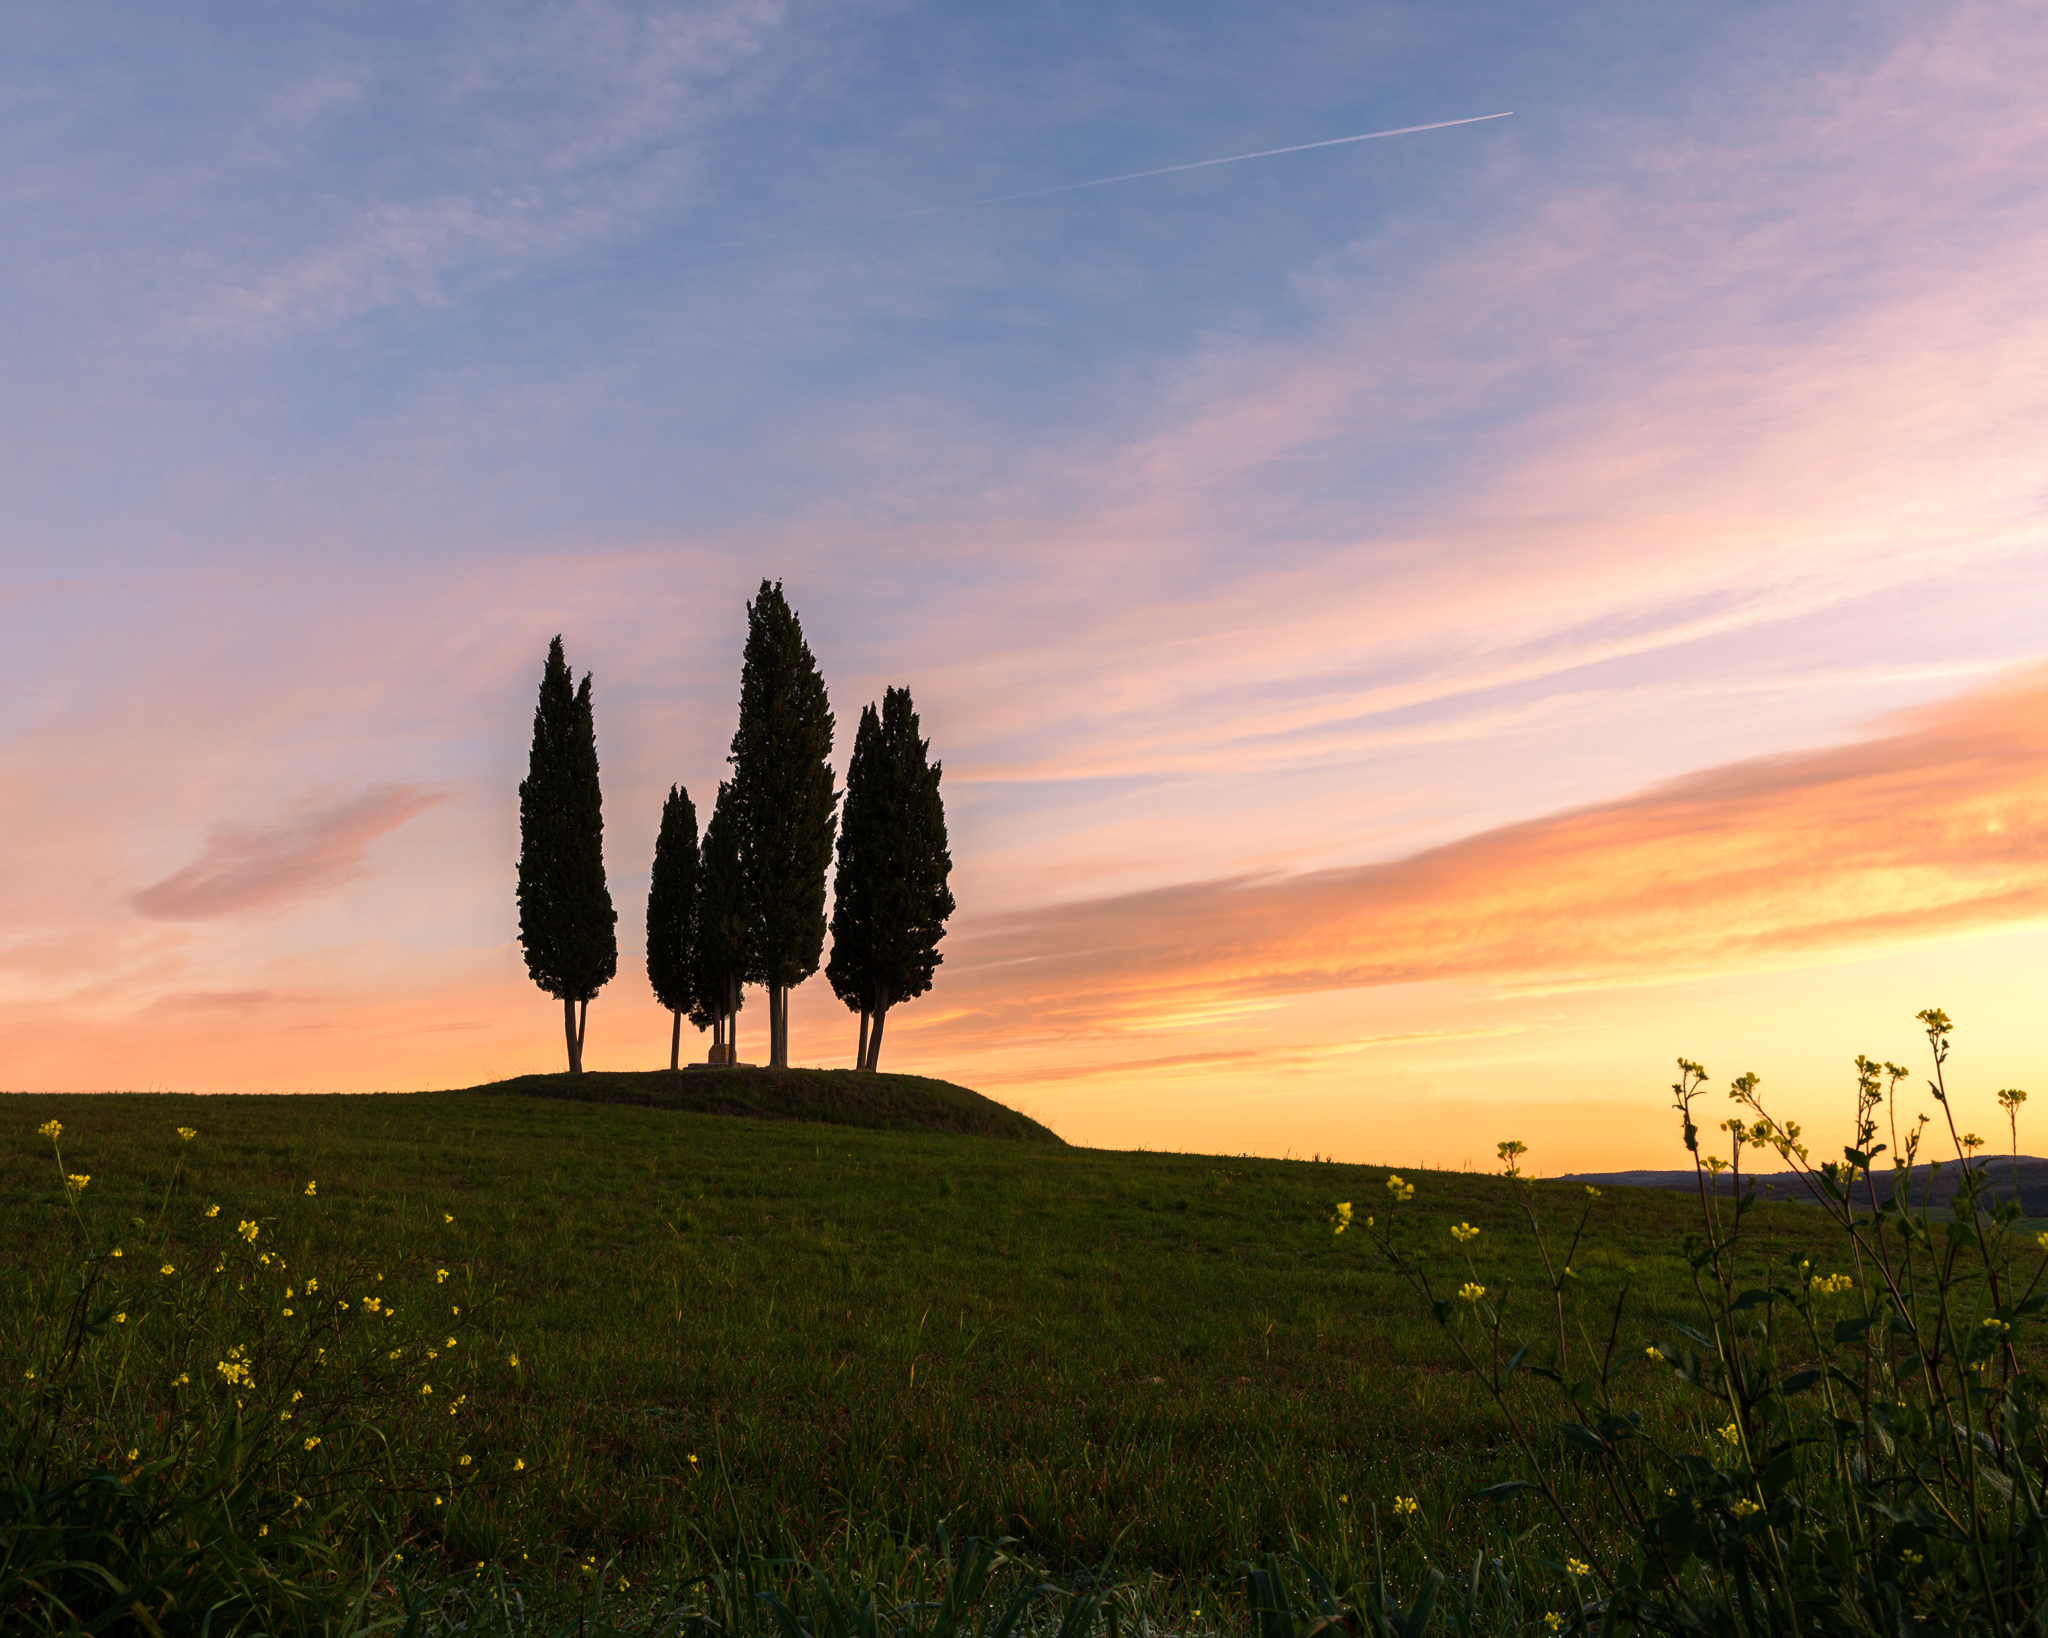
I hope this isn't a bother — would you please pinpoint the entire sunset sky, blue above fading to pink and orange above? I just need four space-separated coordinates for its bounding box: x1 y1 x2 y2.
0 0 2048 1173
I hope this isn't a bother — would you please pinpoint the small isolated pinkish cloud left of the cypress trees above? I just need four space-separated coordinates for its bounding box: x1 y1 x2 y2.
129 784 446 921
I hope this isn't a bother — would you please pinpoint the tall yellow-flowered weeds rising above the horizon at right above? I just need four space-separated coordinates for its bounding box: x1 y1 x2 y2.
1335 1011 2048 1638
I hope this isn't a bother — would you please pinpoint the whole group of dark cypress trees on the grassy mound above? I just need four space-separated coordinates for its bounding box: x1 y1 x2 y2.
518 579 952 1073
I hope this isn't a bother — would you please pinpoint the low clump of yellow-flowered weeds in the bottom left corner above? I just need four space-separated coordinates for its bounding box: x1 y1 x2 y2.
0 1120 503 1632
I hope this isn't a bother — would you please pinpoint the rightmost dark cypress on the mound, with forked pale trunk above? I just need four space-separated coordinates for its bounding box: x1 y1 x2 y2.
825 688 954 1071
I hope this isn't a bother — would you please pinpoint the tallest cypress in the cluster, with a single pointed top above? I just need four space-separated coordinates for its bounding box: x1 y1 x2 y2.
731 579 838 1069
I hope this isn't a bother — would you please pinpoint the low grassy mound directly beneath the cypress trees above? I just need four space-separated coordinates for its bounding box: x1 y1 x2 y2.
442 1069 1063 1145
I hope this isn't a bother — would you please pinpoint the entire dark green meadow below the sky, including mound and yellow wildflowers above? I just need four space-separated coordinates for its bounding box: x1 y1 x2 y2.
16 1048 2048 1638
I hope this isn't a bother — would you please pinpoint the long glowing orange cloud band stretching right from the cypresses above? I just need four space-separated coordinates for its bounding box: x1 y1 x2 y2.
932 672 2048 1038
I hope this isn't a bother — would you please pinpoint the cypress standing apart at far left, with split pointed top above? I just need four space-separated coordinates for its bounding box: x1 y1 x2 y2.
518 637 618 1075
